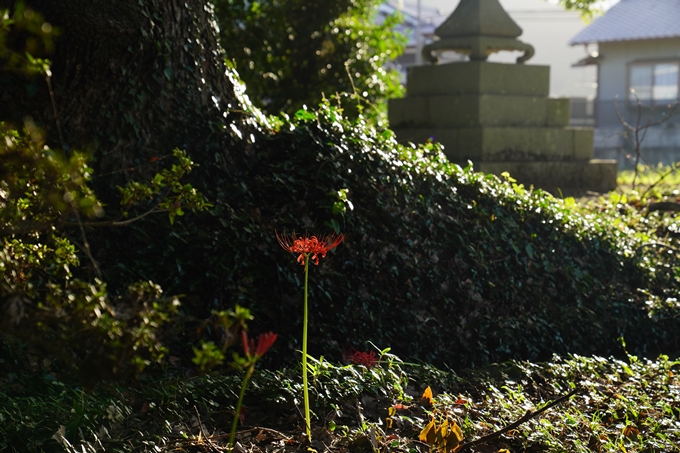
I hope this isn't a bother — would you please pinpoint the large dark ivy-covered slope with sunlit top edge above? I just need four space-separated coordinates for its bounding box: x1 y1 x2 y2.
93 95 680 367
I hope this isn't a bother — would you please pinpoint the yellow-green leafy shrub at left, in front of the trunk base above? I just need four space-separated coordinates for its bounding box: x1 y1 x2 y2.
0 122 206 386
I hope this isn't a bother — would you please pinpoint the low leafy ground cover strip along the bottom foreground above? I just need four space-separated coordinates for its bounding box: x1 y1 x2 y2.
0 351 680 453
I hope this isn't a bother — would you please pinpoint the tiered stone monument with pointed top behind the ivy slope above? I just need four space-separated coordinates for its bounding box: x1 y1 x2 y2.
389 0 617 195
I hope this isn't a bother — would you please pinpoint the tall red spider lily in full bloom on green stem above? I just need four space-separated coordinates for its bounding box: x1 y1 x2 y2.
276 232 345 441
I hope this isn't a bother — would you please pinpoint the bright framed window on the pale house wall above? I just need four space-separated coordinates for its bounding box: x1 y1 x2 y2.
628 62 680 102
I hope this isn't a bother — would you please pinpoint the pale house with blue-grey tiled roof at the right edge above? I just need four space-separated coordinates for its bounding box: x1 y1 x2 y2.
570 0 680 168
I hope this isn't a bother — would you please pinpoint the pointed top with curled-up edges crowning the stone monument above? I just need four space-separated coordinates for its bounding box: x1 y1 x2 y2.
423 0 534 63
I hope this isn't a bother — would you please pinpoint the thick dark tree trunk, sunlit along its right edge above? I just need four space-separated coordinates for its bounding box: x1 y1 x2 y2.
0 0 243 173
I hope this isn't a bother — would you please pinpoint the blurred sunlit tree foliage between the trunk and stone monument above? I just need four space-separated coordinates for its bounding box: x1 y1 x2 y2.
215 0 405 123
